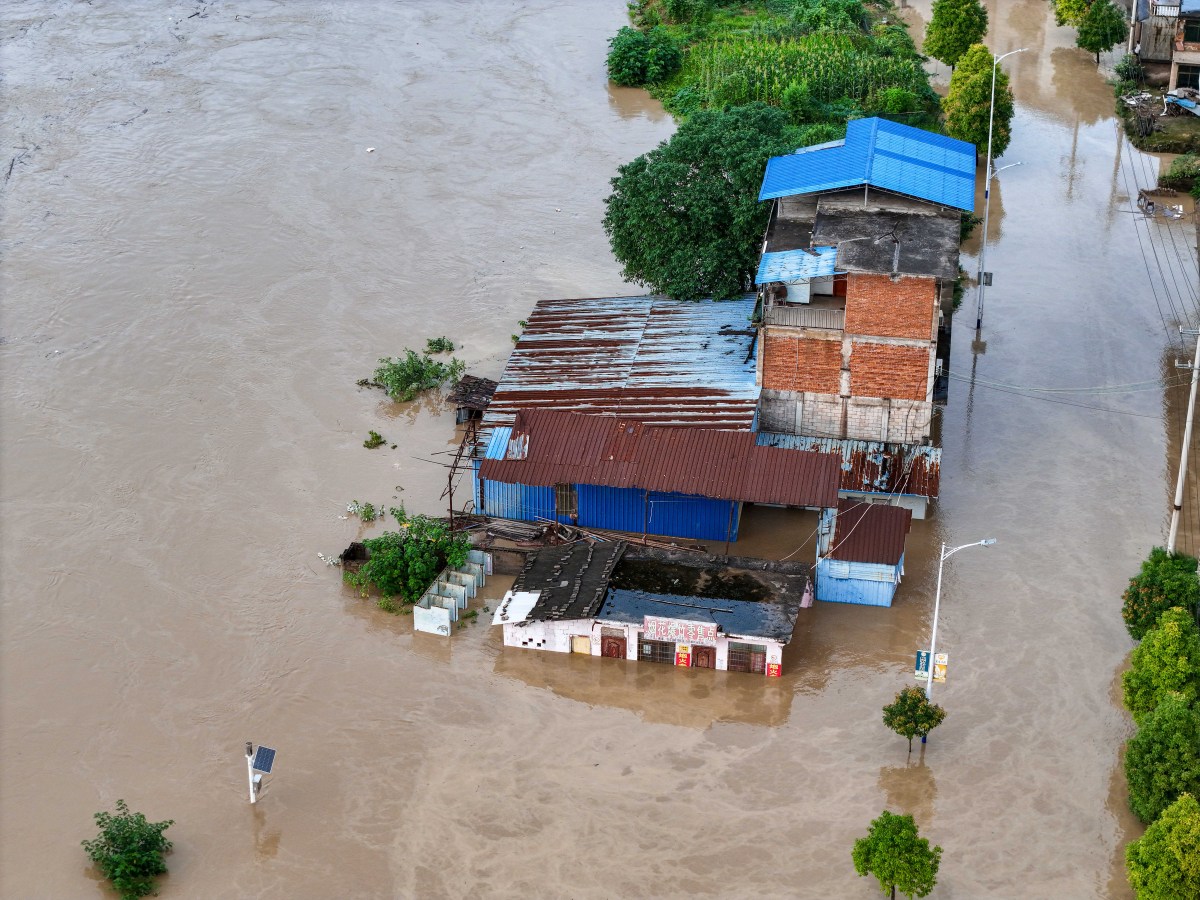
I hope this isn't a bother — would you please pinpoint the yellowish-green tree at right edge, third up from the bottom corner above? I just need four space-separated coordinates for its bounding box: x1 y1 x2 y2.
1121 606 1200 725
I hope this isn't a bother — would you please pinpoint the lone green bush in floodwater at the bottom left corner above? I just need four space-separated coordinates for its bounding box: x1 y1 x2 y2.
83 800 175 900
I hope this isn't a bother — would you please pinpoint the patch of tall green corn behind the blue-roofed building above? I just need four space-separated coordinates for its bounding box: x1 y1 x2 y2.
673 34 928 106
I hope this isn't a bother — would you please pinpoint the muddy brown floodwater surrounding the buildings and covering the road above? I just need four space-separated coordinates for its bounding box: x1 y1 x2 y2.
0 0 1198 899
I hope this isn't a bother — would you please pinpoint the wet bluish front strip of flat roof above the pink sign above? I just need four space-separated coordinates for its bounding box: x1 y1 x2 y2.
595 588 799 644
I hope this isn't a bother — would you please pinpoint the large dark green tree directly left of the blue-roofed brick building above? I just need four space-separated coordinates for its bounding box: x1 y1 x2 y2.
604 103 799 300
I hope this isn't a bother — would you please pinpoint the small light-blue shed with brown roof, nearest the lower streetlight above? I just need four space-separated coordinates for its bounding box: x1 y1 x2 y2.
817 500 912 606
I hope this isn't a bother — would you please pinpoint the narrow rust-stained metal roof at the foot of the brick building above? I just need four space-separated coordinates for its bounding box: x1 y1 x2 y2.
758 431 942 499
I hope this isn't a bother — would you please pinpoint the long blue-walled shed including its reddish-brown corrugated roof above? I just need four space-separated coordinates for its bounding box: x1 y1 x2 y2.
473 409 839 541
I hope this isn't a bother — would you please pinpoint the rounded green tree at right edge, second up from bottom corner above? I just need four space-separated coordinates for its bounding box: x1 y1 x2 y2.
1126 696 1200 823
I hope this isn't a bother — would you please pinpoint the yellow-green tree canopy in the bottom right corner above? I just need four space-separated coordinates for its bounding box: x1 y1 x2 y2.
1126 793 1200 900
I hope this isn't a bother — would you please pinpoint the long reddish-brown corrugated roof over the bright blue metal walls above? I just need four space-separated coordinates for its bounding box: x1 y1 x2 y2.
479 409 840 506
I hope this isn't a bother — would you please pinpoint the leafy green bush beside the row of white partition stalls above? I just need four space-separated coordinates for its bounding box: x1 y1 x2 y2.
342 506 470 612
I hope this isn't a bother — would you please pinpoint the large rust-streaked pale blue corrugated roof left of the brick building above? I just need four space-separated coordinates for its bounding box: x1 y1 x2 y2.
484 296 760 431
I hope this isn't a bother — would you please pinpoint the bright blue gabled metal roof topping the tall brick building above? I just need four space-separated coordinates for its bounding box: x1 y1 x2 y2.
758 119 976 212
